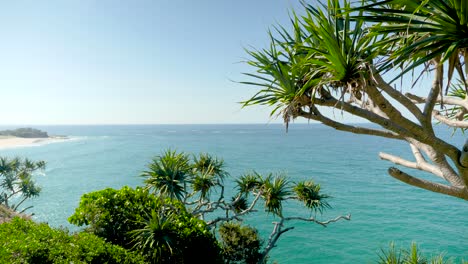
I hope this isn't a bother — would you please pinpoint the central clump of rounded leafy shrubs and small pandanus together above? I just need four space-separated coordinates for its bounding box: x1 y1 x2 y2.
69 150 350 263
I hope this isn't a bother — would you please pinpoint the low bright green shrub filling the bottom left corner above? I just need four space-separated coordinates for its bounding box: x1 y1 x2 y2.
0 218 145 264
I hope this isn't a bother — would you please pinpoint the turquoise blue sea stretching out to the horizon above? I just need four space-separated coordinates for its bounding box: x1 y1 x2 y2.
0 124 468 264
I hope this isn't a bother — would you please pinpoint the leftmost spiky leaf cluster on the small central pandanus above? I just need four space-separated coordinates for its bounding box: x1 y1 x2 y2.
141 150 191 200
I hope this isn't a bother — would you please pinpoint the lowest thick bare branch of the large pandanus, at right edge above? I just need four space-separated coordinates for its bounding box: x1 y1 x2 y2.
388 167 468 200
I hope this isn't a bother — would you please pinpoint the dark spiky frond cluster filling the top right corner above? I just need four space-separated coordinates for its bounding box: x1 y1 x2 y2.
359 0 468 87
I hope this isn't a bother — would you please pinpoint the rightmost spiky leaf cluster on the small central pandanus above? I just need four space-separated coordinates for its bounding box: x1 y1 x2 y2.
293 181 330 213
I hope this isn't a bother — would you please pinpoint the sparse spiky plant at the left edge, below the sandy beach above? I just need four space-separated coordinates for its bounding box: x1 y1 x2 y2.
0 157 46 212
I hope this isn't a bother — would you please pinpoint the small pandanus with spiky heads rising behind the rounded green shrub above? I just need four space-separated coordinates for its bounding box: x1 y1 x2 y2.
143 151 351 263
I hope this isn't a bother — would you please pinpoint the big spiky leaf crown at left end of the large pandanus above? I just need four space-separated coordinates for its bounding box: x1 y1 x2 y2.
242 0 378 125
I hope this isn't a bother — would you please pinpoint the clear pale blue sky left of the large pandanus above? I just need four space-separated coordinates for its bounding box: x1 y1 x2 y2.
0 0 314 124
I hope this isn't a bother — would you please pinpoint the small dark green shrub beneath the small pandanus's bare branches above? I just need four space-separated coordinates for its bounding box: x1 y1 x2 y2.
219 222 262 264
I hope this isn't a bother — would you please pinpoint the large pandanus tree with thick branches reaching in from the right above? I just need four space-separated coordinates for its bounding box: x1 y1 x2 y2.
243 0 468 200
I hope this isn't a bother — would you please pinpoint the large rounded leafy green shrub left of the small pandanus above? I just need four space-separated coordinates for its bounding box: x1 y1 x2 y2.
69 187 222 263
